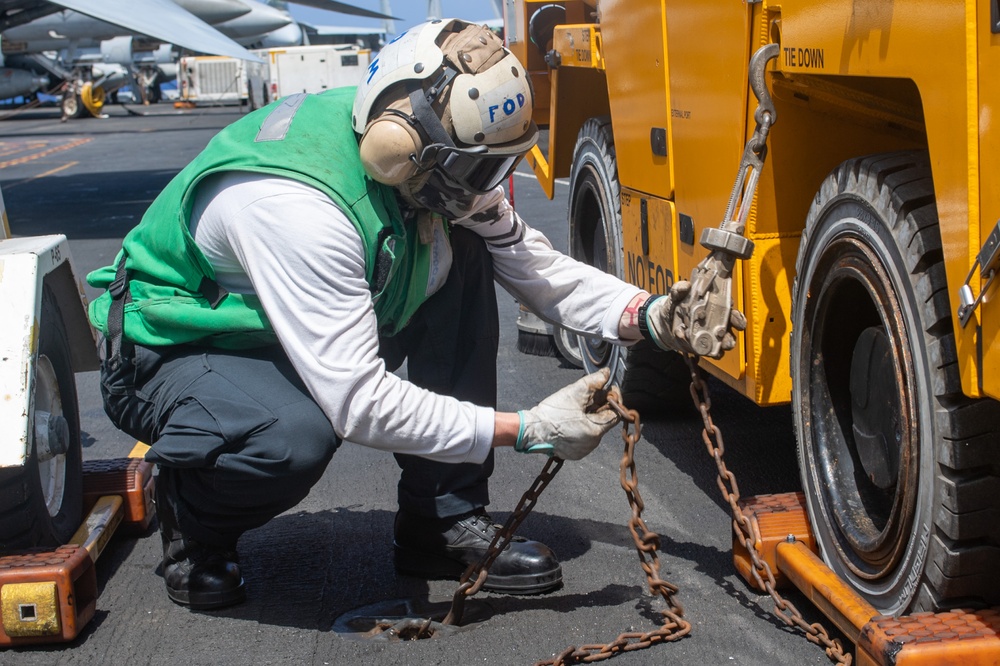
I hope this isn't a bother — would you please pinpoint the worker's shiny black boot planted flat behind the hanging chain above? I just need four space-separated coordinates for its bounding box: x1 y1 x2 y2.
394 509 562 594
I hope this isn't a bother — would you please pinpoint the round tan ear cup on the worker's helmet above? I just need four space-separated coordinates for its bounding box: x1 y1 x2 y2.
360 114 423 185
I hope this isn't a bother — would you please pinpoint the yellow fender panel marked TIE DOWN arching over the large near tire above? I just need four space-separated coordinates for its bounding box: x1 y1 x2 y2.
775 0 988 395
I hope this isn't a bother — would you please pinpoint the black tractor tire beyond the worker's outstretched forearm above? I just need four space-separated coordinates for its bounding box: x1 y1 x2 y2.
569 117 625 384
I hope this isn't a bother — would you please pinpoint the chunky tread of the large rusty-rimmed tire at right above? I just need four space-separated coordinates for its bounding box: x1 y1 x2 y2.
793 151 1000 610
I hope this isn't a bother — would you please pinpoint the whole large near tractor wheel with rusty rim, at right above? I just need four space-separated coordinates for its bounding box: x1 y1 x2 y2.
791 152 1000 613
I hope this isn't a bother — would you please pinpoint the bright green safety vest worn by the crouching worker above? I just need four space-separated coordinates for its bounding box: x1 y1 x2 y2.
87 88 444 349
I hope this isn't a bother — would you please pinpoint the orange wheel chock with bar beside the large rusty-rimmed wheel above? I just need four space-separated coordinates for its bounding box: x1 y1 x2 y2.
733 493 1000 666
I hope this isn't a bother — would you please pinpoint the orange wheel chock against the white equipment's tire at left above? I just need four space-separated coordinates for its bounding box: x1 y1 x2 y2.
0 445 154 647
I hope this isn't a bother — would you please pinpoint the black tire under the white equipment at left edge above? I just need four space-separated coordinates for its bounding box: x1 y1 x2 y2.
0 286 83 552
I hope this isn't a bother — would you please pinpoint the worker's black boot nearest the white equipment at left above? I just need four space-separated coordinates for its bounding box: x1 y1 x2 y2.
156 474 246 610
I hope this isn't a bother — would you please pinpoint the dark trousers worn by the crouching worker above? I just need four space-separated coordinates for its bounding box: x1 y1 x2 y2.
101 228 499 547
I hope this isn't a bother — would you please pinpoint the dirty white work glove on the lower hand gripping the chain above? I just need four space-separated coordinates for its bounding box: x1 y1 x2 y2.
514 368 621 460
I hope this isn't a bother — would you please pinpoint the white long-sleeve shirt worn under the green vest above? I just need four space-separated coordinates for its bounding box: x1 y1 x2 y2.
191 172 639 463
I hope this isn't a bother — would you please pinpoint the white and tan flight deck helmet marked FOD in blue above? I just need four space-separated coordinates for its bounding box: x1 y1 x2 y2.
352 19 538 194
